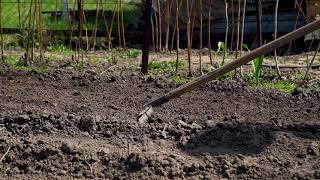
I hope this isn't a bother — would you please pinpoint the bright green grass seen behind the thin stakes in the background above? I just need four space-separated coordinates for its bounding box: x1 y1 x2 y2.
1 0 141 30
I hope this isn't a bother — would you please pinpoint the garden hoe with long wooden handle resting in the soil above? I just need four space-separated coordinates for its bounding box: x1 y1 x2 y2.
137 20 320 123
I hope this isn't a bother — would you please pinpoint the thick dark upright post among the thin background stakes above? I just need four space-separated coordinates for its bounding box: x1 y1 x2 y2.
141 0 152 74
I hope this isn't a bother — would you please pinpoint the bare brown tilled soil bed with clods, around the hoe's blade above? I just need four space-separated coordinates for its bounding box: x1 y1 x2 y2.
0 71 320 179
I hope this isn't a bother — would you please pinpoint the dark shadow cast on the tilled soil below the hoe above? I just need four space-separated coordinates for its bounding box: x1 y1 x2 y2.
181 123 320 156
